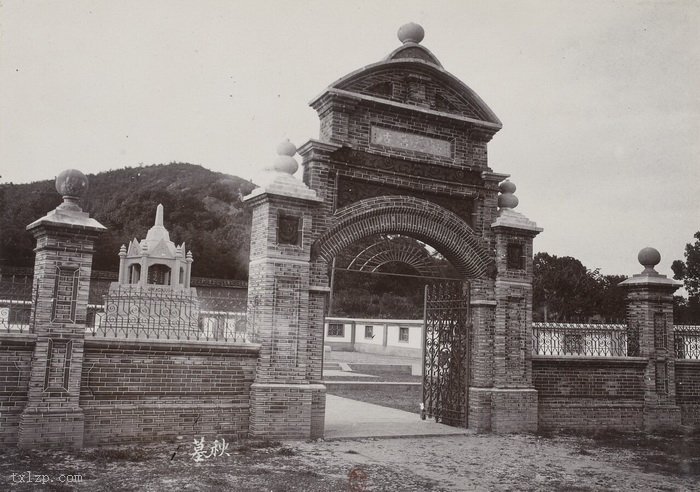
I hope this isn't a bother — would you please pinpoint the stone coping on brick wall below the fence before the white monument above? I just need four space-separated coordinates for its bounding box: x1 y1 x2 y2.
85 337 260 356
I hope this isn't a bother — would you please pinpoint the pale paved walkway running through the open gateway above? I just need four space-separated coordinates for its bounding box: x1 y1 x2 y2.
323 395 468 439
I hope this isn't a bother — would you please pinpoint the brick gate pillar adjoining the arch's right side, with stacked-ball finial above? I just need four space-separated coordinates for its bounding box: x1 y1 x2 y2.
491 181 542 432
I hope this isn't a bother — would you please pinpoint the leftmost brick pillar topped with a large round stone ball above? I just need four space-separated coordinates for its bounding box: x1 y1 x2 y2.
18 169 105 448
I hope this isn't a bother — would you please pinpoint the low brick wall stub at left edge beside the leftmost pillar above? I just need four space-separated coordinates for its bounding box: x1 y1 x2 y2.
0 334 36 446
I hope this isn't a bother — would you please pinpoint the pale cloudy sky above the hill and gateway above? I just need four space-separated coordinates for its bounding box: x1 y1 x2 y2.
0 0 700 275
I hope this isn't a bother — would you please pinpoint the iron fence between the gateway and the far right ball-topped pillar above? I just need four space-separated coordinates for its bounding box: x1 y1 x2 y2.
532 323 639 357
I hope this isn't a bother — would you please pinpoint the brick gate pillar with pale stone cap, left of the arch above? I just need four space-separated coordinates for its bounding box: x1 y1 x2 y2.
245 142 325 439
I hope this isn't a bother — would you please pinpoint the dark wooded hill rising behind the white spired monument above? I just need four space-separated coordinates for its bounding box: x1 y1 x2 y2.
0 163 255 279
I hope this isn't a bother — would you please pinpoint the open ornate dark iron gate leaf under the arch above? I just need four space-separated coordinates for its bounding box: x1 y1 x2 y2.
421 281 471 427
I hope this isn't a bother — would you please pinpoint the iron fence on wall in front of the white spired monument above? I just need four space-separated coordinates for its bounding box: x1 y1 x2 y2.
87 286 255 343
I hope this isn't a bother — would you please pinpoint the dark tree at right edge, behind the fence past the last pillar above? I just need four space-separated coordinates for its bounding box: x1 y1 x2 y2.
671 231 700 324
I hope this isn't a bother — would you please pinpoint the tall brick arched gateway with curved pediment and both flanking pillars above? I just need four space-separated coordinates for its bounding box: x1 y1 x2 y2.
246 24 541 439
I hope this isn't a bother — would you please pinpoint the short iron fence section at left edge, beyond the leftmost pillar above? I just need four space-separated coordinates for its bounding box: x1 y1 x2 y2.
0 275 36 333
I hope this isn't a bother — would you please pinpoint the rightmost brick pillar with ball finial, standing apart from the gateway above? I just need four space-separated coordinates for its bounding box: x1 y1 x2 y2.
619 248 681 430
